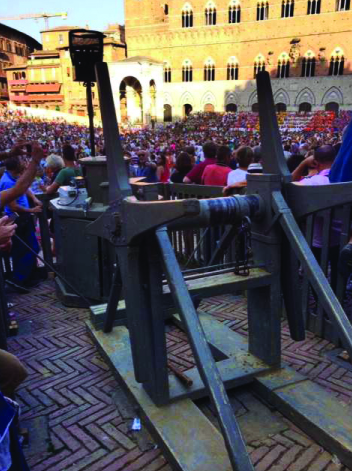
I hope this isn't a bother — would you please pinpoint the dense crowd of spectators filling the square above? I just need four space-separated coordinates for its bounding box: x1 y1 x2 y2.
0 107 352 471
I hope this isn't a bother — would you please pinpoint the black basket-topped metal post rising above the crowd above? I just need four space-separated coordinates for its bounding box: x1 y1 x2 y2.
69 29 105 157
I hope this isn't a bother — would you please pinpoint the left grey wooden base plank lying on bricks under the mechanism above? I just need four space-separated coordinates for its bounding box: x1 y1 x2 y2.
87 321 232 471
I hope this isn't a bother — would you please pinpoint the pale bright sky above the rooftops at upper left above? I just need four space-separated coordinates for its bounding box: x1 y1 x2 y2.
0 0 124 42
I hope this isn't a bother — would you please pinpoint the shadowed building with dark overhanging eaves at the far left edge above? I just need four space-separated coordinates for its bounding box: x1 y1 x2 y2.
0 23 41 105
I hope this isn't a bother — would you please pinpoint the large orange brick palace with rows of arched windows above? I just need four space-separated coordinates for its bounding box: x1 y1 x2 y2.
118 0 352 120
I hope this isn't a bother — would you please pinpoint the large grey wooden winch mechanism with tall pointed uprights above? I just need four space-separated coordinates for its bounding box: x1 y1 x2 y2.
88 63 352 471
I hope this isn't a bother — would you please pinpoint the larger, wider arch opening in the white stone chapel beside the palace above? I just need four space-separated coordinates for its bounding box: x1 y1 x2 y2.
120 77 143 124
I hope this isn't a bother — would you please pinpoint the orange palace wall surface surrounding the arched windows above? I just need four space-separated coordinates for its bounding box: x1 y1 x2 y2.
125 0 352 113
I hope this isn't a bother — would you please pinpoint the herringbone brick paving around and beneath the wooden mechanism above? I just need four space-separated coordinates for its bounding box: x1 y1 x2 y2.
9 282 352 471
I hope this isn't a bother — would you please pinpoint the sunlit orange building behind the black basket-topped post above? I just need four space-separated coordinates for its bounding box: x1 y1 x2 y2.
6 25 126 116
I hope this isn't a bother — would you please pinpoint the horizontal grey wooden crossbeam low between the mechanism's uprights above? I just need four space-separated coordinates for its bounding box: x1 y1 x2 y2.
90 268 271 329
